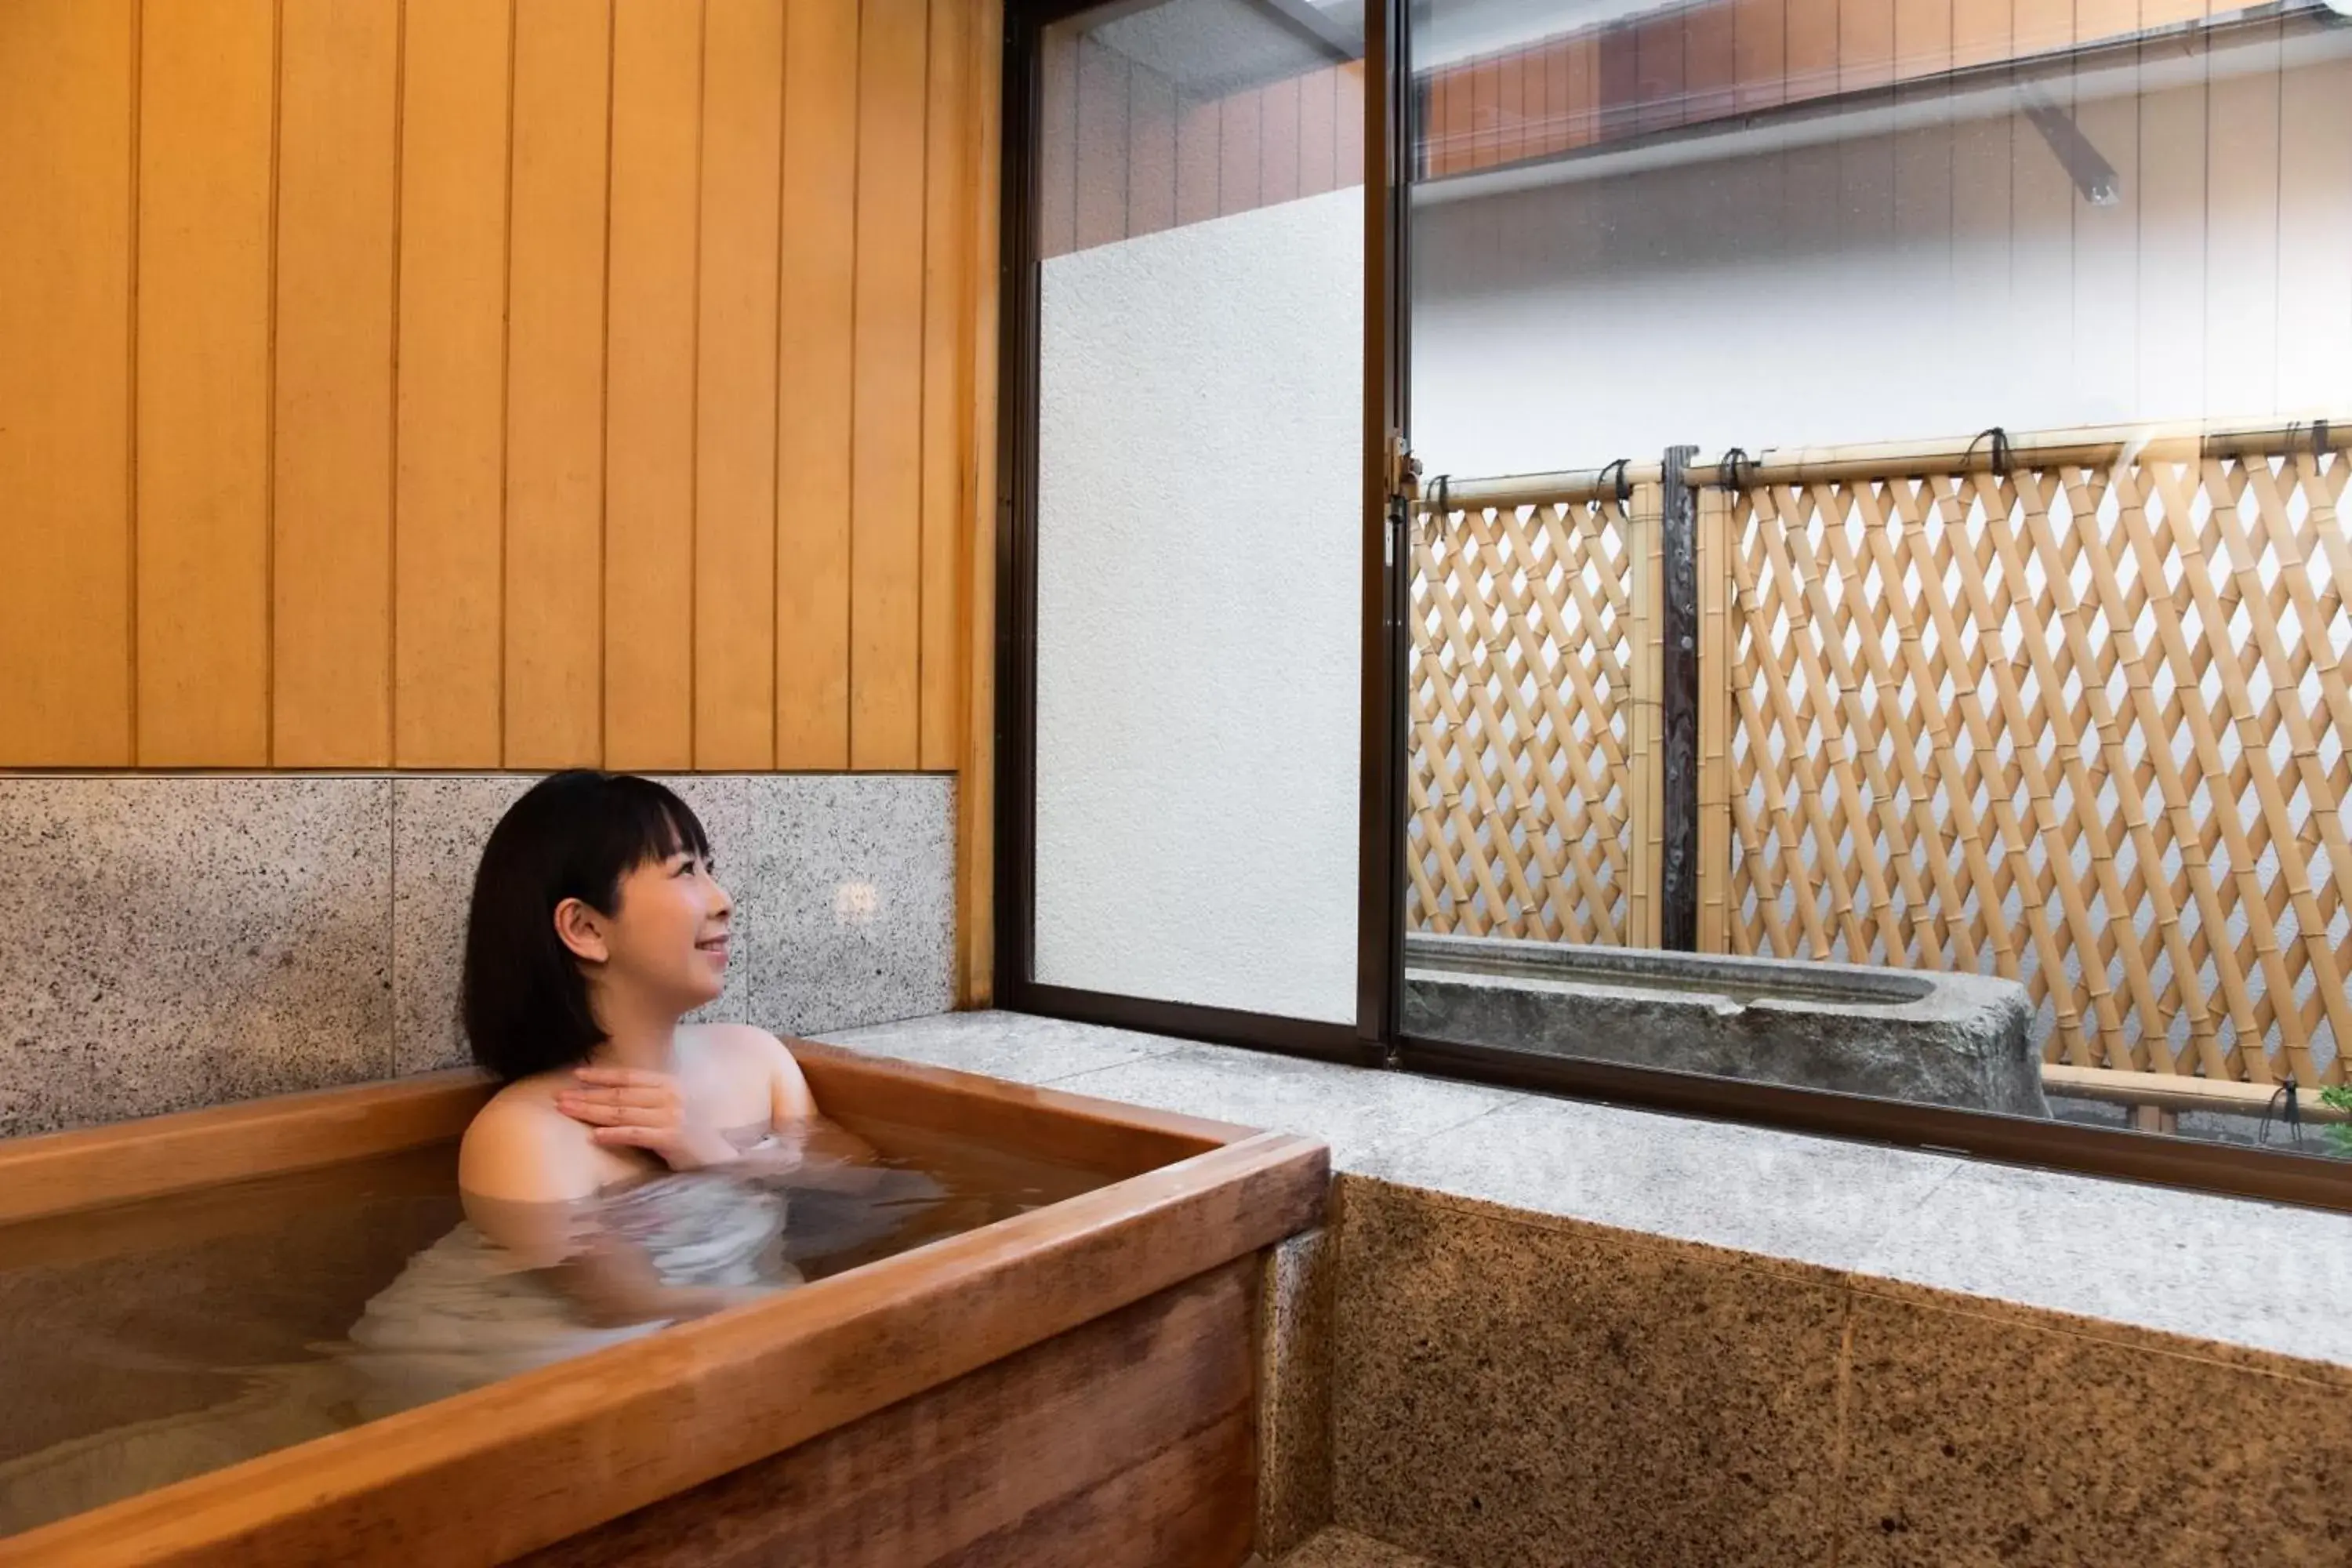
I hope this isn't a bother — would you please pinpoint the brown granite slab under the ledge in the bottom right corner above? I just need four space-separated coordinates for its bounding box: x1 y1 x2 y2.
1837 1286 2352 1568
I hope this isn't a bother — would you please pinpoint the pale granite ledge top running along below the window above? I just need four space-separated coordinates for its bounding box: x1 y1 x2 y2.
823 1011 2352 1375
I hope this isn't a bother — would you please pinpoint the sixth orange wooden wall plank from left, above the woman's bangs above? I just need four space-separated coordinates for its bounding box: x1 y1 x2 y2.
604 0 703 769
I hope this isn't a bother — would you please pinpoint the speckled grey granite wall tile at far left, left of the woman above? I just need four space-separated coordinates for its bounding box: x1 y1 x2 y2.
0 779 393 1135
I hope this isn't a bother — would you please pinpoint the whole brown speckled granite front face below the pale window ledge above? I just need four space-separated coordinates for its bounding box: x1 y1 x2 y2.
1334 1175 2352 1568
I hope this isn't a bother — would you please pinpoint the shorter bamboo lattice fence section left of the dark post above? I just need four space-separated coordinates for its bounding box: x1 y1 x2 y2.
1406 470 1661 947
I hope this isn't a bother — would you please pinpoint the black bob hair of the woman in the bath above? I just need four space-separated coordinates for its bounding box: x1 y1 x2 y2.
461 769 710 1083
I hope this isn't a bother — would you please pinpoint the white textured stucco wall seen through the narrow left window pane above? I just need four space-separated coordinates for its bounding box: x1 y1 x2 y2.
1035 191 1364 1022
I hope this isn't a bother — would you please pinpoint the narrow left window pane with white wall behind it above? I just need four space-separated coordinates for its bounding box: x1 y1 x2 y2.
1033 0 1364 1022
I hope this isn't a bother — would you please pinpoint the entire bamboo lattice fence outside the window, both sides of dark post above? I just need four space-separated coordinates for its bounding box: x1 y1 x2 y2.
1409 426 2352 1088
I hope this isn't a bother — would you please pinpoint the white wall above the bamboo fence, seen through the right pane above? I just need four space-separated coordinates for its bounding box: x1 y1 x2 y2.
1414 59 2352 477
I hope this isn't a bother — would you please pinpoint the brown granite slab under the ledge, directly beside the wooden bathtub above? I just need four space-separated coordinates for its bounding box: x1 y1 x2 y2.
1334 1180 1846 1568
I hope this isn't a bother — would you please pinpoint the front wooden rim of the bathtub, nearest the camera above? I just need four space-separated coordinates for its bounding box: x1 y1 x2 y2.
0 1133 1329 1568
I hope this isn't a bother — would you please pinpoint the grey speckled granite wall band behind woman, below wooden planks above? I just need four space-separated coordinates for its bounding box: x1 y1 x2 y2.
0 774 955 1138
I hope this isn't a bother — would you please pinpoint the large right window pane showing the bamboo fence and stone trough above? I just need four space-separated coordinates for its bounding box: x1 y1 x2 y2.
1406 0 2352 1154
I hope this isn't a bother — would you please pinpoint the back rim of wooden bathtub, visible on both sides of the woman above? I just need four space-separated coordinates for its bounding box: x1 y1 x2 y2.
0 1039 1251 1225
